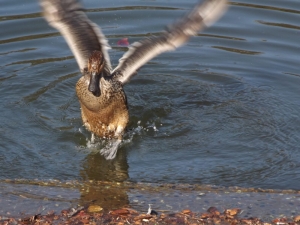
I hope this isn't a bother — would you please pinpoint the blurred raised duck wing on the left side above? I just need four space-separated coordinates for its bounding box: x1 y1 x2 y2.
40 0 111 73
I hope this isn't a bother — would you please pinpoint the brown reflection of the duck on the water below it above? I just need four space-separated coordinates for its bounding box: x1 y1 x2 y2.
80 149 129 209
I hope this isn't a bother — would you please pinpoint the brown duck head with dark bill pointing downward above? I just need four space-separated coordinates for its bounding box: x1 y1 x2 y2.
88 51 105 97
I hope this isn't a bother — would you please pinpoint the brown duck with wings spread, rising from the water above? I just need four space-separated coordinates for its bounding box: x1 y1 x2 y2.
40 0 227 147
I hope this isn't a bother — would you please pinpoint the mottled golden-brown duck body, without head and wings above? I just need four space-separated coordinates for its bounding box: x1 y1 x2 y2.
76 76 129 139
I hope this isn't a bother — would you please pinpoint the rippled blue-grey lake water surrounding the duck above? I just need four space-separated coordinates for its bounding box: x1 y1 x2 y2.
0 0 300 214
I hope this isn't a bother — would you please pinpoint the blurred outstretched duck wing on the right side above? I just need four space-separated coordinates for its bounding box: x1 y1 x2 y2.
113 0 227 83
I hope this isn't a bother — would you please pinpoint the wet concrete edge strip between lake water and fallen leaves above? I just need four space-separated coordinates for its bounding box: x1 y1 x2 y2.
0 179 300 224
